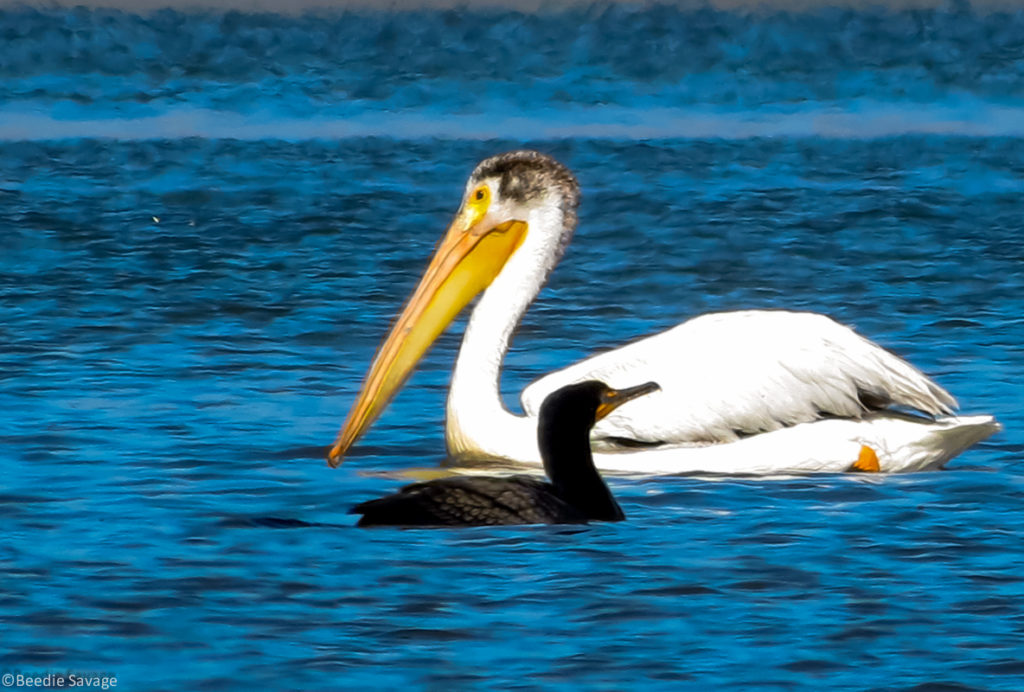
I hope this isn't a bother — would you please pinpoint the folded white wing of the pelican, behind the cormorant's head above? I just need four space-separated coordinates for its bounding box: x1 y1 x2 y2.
522 310 956 443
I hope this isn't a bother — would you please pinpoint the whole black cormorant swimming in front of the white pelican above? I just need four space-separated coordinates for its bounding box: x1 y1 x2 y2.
352 381 657 526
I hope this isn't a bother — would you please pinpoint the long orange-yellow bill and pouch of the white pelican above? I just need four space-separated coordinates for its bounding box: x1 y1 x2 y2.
328 204 526 468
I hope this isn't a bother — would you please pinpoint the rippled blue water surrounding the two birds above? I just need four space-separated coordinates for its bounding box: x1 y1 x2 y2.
0 7 1024 690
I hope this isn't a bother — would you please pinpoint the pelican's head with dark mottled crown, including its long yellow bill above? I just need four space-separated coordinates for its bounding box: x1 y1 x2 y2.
328 150 580 467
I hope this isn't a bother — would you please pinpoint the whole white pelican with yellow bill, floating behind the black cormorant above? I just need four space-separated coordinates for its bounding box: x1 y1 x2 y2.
329 152 1001 474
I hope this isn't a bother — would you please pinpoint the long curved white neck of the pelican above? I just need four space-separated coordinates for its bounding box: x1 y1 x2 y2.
444 203 574 464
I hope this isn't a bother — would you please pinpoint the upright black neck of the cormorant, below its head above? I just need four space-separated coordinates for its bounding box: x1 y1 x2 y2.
538 425 626 521
